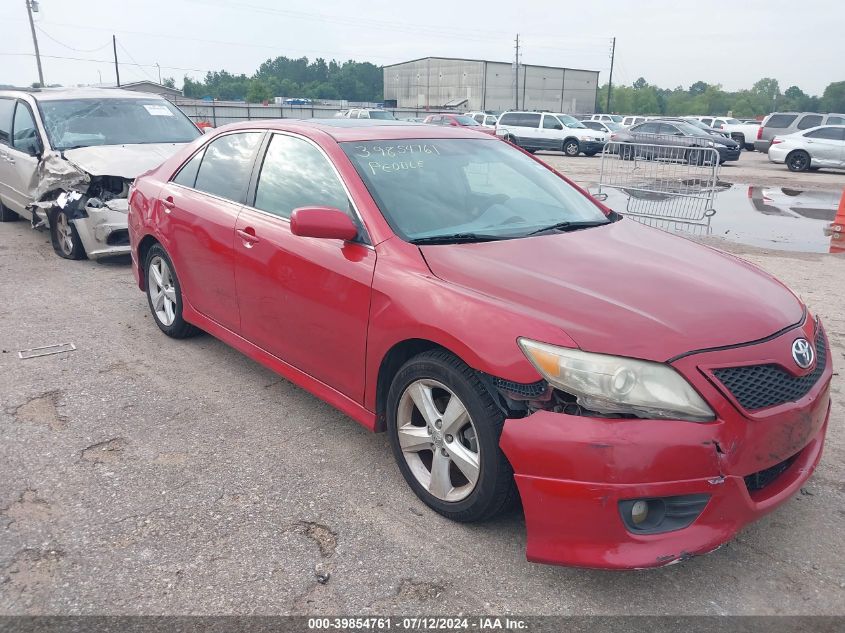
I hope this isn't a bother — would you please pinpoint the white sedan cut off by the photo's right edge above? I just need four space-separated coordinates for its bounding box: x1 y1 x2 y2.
769 125 845 171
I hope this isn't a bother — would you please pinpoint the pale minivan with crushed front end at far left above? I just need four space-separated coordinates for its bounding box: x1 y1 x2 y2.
0 88 201 259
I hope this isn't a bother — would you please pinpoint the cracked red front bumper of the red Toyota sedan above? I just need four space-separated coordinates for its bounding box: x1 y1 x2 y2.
500 324 832 569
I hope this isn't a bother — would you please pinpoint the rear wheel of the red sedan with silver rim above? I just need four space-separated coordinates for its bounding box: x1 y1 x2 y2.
144 244 200 338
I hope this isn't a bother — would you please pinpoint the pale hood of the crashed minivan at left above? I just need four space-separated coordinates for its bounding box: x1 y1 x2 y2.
64 143 185 180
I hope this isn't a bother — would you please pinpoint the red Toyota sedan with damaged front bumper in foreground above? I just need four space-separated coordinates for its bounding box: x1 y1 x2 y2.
129 119 832 568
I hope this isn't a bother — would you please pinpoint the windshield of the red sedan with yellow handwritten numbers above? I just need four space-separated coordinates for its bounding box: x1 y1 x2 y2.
340 139 607 241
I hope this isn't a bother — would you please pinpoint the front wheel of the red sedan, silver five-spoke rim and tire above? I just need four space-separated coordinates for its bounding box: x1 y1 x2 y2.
387 350 517 522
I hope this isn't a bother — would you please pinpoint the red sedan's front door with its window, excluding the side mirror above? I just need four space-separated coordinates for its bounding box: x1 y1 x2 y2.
235 133 376 402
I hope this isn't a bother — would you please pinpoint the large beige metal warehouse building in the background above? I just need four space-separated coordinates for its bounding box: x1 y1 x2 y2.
384 57 599 114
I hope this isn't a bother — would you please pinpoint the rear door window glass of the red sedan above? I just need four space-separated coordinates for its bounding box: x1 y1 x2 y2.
196 132 262 202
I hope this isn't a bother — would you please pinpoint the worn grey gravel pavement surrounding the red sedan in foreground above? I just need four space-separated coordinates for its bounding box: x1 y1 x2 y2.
0 195 845 615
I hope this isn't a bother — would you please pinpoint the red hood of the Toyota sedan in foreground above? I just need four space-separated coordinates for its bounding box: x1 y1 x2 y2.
420 219 804 361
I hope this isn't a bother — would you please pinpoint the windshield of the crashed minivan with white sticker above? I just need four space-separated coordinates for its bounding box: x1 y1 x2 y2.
38 99 200 150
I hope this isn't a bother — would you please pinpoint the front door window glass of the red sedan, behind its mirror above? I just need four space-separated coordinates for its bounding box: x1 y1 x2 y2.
253 134 349 218
